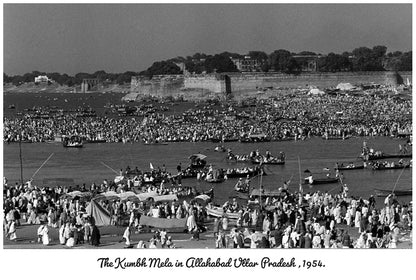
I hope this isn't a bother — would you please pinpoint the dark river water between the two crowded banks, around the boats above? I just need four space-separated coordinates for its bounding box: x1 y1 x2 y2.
3 137 412 203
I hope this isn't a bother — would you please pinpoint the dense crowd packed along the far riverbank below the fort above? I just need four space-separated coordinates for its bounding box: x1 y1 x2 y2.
3 94 412 143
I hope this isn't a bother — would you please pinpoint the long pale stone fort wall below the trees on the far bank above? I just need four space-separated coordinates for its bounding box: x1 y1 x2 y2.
125 71 412 99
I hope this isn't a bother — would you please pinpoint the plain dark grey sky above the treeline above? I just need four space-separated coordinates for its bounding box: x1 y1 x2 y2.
3 4 412 75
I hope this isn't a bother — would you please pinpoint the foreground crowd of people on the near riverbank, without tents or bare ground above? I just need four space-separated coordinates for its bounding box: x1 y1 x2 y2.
3 173 413 248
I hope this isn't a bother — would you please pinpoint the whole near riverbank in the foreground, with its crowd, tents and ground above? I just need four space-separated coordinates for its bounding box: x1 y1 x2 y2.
3 173 412 249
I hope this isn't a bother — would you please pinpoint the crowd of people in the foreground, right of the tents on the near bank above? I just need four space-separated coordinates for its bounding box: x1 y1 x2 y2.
214 191 412 248
